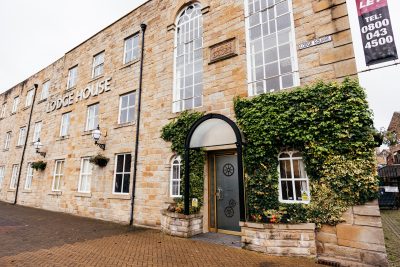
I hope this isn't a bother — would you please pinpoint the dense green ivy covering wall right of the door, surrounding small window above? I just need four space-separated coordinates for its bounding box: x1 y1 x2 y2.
234 80 378 225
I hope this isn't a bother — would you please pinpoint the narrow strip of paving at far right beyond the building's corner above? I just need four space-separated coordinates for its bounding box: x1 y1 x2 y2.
381 210 400 267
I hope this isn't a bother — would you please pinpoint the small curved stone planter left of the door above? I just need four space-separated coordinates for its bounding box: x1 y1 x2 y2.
161 210 203 238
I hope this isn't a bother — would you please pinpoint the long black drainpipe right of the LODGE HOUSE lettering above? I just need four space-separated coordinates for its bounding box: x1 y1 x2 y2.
129 23 147 226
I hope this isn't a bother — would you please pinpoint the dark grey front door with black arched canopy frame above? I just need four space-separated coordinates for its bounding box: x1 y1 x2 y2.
184 113 246 234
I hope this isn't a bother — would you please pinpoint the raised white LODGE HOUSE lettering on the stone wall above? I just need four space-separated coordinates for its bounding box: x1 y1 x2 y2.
46 77 111 113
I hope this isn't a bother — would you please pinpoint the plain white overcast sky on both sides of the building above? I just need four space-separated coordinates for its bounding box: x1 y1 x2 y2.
0 0 400 129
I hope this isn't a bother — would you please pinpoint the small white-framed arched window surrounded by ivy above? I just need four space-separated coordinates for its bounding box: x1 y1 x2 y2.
279 151 310 203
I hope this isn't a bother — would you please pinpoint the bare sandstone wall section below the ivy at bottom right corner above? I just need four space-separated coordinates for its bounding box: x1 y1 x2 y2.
316 201 388 267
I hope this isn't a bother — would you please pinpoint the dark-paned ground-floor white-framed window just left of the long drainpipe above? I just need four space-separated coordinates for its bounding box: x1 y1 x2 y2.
113 154 132 194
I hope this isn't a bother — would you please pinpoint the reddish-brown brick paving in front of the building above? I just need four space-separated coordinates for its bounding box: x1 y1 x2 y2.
0 202 318 267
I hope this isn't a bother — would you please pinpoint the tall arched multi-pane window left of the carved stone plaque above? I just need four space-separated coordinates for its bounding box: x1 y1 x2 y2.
172 3 203 112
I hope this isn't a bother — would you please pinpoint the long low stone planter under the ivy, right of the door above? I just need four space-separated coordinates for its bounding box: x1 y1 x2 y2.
240 222 317 258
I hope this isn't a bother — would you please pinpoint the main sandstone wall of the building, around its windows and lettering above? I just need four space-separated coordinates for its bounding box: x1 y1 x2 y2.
0 0 356 228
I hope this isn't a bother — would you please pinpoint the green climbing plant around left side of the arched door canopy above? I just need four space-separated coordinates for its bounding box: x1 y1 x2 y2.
161 111 205 213
